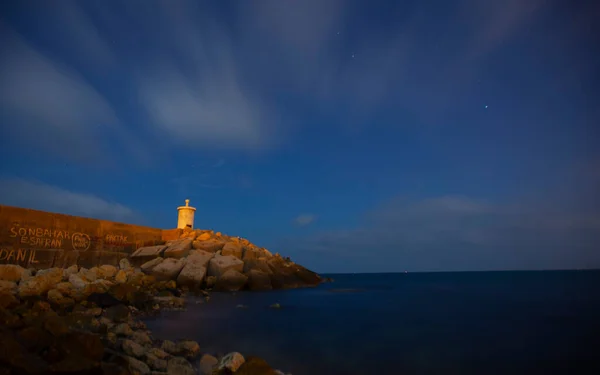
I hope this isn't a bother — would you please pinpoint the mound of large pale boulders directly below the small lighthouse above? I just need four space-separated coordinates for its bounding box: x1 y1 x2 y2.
131 229 322 291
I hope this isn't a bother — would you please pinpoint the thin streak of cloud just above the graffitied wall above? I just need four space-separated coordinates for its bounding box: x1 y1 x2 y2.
0 178 139 223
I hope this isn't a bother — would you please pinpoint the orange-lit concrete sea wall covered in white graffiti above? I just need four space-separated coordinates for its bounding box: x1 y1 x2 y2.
0 205 166 269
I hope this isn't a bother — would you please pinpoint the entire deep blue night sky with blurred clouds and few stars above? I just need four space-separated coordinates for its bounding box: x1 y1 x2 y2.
0 0 600 272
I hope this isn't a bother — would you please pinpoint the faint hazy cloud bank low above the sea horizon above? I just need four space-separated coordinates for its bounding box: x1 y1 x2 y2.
285 196 600 272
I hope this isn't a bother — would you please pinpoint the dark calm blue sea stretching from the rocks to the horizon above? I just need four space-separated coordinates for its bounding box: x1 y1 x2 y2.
147 271 600 375
